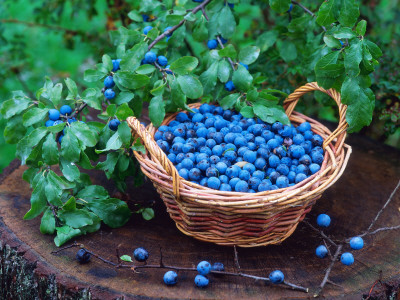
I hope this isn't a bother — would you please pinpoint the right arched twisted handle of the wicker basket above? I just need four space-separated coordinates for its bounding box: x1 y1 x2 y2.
283 82 349 150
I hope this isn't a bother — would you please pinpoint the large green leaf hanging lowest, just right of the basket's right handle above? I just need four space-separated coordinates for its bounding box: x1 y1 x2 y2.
341 77 375 132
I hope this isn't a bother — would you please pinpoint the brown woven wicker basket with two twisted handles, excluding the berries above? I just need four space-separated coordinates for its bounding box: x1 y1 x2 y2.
127 83 351 247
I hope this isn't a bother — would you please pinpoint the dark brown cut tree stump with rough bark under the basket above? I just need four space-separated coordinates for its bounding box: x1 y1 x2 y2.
0 135 400 299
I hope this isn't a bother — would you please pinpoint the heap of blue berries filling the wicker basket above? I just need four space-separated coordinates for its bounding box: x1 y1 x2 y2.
154 104 324 193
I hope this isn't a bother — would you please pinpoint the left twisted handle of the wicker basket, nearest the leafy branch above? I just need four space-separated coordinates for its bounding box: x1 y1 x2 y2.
126 117 180 199
